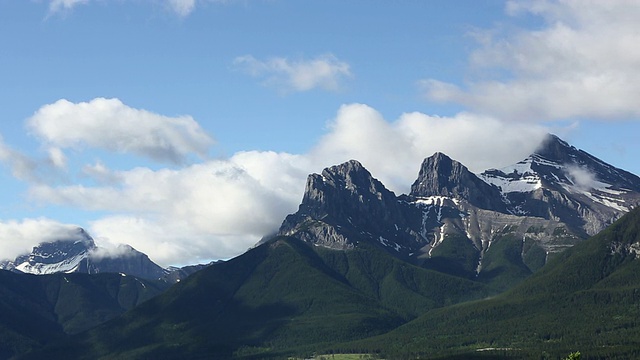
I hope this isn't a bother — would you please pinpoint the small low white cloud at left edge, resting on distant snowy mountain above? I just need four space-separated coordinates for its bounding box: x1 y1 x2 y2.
0 218 84 259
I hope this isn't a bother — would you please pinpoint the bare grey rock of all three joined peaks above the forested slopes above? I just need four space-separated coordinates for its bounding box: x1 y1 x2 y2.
277 135 640 284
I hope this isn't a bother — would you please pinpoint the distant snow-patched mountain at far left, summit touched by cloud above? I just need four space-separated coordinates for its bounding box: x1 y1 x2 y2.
0 228 202 282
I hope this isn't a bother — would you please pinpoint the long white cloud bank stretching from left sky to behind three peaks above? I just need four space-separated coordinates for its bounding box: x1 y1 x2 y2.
20 104 545 265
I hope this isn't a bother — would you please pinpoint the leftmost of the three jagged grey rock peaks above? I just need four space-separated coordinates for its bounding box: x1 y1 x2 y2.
278 160 421 252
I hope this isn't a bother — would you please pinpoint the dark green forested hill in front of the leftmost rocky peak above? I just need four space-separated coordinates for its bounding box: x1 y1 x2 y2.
27 237 493 359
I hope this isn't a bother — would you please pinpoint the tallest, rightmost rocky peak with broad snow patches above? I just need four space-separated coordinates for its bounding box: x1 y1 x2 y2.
480 135 640 235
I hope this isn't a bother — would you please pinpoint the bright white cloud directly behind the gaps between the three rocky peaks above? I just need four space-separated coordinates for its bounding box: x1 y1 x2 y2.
311 104 547 192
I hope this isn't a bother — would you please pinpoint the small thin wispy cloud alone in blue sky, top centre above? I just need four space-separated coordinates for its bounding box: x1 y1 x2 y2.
233 54 353 92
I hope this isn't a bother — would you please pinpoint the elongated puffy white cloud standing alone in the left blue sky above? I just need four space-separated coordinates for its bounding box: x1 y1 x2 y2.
27 98 213 163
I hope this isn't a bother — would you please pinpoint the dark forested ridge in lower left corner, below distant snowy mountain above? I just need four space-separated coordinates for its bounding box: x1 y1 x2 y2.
0 270 168 359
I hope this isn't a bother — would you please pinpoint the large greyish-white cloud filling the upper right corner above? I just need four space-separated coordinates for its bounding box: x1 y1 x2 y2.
421 0 640 121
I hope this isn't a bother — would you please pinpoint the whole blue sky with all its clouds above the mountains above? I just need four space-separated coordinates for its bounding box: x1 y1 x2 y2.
0 0 640 266
